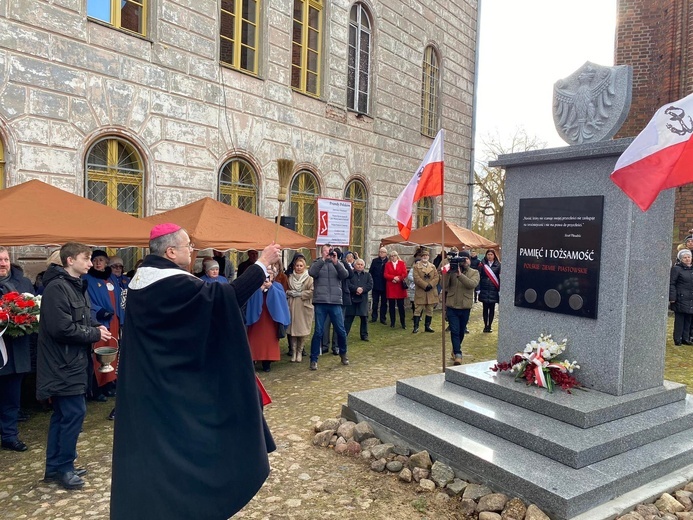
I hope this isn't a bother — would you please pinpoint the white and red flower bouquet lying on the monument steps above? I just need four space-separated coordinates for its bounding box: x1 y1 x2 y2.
491 334 583 393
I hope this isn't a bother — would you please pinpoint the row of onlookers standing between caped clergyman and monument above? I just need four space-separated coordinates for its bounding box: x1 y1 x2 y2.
239 244 501 372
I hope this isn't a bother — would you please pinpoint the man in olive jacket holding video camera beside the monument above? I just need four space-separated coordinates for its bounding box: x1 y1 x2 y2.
444 251 479 365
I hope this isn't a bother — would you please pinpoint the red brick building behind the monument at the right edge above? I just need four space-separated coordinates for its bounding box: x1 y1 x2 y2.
614 0 693 244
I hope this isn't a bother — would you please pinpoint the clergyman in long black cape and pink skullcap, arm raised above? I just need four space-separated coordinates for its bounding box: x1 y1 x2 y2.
110 224 280 520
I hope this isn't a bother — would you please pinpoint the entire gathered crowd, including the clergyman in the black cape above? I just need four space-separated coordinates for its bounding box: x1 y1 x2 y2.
8 224 693 520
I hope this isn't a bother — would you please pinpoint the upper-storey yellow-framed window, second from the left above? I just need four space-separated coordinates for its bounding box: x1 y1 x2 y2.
219 0 260 74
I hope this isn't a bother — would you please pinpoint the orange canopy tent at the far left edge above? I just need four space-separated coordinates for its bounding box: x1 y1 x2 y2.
0 180 151 247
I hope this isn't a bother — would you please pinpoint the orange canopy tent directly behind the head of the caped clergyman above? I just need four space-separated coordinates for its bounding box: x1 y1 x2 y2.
143 197 315 251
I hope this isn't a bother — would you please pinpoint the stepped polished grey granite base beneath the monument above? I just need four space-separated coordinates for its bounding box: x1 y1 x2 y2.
348 361 693 520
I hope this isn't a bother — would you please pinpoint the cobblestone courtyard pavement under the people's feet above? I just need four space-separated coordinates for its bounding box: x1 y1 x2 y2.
0 306 496 520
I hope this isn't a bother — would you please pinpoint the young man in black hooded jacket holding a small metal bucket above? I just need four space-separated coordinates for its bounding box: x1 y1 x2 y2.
36 242 111 489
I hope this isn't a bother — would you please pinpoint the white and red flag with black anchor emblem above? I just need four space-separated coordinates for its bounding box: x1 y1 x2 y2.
611 94 693 211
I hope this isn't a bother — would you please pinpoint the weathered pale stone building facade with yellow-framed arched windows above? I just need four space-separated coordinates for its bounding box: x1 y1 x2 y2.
0 0 477 266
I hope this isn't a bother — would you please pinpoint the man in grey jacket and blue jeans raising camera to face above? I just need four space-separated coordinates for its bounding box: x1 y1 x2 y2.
308 244 350 370
